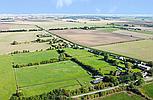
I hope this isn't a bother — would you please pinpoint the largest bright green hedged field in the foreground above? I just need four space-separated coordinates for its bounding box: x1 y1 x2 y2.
15 61 91 96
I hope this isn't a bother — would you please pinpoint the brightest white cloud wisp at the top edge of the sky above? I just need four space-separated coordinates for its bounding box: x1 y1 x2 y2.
56 0 72 8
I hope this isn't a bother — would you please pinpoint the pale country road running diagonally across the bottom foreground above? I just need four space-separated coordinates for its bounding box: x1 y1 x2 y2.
71 86 119 98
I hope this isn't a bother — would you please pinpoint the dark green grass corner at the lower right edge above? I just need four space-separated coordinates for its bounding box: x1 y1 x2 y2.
140 83 153 99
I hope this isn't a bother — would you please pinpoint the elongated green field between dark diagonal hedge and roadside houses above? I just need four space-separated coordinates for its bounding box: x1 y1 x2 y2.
65 49 117 74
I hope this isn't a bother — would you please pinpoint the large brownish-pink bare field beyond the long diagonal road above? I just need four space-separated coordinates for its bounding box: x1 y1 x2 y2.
51 30 139 46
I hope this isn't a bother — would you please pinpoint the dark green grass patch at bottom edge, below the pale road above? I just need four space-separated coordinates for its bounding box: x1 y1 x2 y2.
94 92 144 100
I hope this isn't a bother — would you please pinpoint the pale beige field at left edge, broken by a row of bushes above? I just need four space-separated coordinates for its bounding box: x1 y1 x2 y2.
0 32 50 54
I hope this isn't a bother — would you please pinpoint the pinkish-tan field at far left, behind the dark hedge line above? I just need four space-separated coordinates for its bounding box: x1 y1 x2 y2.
0 23 37 31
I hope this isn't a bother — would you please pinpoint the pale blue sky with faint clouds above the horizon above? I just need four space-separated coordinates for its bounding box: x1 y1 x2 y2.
0 0 153 14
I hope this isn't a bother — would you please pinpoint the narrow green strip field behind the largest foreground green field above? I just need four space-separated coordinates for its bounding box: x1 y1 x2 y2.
12 50 58 64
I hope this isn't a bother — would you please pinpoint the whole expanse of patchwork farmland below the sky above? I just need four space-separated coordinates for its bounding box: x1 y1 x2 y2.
0 15 153 100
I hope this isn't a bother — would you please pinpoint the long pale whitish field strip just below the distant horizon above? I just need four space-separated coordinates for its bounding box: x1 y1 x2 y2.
14 19 124 29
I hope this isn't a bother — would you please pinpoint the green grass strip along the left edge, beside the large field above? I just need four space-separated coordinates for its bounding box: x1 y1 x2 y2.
0 56 16 100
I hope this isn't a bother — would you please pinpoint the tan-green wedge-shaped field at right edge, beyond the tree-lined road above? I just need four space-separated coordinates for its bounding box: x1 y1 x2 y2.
94 40 153 61
